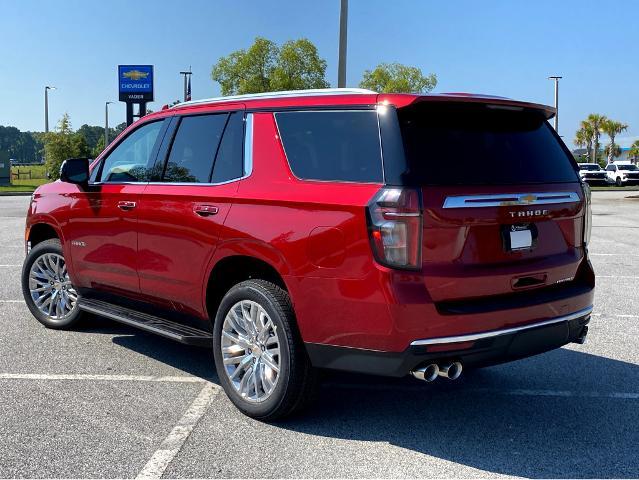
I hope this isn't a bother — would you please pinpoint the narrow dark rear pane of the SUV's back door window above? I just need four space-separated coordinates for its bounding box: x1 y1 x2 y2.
211 112 244 183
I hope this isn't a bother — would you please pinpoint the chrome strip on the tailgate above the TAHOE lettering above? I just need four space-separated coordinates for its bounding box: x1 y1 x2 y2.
443 192 579 208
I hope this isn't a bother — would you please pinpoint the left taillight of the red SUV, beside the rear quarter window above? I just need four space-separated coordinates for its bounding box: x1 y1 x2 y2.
368 187 422 269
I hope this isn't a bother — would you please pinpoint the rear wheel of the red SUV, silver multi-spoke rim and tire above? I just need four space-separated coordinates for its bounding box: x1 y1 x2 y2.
213 280 316 420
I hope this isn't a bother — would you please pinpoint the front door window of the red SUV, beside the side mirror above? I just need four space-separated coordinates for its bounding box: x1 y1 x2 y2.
98 120 164 183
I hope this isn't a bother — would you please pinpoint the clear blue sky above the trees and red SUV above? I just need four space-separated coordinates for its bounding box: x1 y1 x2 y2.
0 0 639 145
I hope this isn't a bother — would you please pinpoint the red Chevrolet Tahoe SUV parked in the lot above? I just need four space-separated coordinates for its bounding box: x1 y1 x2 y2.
22 89 595 419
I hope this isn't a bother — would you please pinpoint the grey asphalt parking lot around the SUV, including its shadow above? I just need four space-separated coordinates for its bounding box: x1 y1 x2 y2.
0 191 639 478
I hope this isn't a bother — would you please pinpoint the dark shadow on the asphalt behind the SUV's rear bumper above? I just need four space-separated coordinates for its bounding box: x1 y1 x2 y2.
280 349 639 478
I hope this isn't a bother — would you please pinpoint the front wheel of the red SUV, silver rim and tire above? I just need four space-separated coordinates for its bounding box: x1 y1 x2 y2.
22 239 82 329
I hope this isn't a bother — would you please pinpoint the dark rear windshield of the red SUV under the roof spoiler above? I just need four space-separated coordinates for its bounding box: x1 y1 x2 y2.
398 103 577 185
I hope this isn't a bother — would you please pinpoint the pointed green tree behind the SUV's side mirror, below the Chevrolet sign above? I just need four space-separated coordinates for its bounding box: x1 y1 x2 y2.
44 113 91 180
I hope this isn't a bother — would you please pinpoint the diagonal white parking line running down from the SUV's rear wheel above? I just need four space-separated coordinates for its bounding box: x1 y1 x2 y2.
136 383 220 479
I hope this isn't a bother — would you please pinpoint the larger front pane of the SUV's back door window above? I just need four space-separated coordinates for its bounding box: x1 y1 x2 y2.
163 114 228 183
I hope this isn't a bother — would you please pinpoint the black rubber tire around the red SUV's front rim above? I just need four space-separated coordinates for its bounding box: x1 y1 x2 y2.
22 238 84 330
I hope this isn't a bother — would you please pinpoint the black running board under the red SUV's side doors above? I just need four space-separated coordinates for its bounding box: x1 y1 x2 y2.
78 298 213 347
